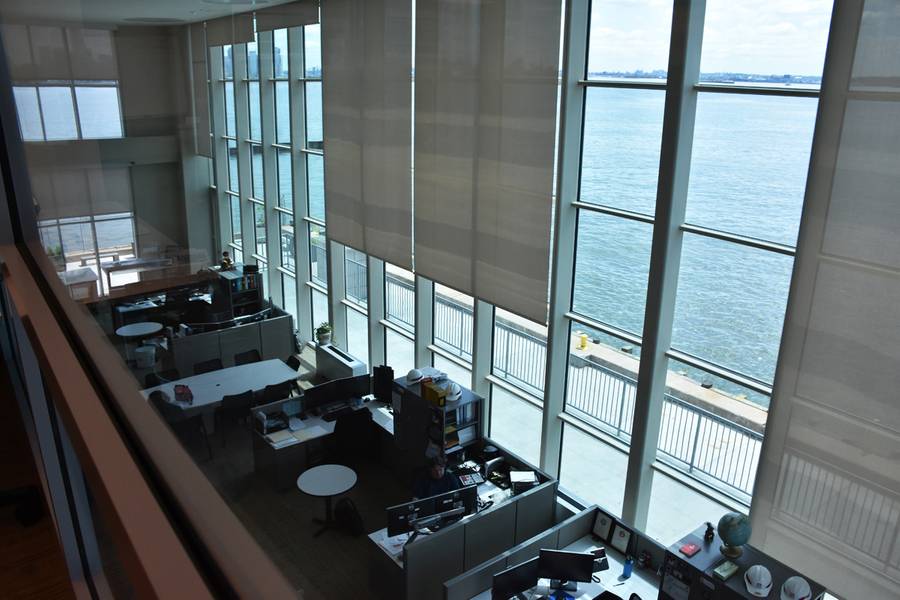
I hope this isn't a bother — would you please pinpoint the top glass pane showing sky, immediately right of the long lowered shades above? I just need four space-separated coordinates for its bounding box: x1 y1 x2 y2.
588 0 672 79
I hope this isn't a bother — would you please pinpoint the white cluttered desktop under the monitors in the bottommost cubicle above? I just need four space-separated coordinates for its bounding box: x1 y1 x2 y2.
472 535 659 600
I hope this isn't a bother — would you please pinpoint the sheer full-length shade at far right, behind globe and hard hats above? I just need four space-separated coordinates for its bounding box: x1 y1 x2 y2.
750 0 900 598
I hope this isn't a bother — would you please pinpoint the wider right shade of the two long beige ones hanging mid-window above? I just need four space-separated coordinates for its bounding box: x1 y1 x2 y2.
414 0 560 323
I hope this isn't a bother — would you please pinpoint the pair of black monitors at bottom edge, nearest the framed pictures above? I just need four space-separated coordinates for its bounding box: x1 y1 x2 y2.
491 549 602 600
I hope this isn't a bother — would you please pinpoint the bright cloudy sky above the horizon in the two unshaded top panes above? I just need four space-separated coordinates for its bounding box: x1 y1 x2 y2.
588 0 832 75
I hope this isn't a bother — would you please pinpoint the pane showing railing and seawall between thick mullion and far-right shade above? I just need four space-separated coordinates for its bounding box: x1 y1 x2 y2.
658 360 769 503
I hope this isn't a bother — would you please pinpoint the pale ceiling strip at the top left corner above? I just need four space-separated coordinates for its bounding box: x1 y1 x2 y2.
0 0 292 25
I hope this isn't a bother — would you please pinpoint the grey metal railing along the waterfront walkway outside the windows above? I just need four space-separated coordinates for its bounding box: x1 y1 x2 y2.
385 275 763 501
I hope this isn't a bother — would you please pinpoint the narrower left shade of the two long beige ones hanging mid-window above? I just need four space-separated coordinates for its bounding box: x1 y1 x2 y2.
322 0 412 269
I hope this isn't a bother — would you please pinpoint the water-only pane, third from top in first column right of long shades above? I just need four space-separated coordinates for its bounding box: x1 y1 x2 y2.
572 210 653 335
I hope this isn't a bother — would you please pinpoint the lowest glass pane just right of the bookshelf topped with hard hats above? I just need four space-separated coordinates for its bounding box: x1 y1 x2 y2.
490 385 543 465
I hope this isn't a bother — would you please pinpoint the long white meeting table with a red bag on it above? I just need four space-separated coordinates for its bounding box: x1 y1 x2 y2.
139 358 297 431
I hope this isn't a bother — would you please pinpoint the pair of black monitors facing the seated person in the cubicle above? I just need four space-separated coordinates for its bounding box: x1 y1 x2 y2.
387 485 486 543
